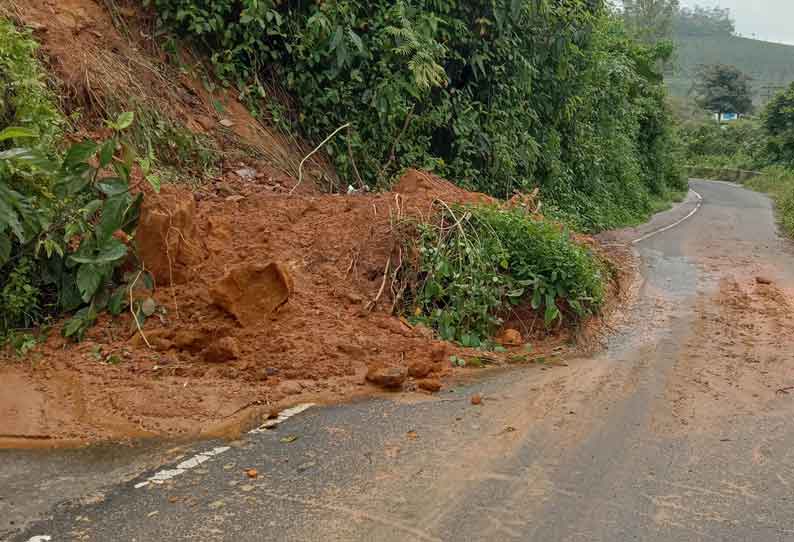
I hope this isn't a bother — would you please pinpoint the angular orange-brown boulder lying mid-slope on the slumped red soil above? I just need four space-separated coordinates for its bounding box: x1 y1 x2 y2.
210 263 292 327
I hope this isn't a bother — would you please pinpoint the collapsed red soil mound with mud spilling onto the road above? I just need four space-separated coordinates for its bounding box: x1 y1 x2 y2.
0 171 524 446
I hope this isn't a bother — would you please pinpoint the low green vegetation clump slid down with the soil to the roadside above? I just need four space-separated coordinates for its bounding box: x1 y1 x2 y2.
406 204 606 347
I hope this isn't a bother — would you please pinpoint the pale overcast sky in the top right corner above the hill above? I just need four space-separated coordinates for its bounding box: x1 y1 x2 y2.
681 0 794 45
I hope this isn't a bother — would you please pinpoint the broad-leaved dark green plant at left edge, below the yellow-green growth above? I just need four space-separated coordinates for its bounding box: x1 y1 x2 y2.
0 113 148 340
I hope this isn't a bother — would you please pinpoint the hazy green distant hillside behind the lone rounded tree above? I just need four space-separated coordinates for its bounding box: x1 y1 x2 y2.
668 35 794 104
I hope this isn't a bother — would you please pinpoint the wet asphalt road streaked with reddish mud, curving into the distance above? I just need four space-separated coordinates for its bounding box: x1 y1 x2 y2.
0 181 794 542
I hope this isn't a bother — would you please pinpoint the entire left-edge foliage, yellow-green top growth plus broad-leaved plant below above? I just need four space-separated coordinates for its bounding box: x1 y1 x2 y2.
0 21 152 342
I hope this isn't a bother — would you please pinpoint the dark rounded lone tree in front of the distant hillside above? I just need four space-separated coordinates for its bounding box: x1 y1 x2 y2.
693 64 753 118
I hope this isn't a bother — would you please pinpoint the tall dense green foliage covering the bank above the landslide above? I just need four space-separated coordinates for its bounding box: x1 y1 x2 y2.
151 0 682 230
